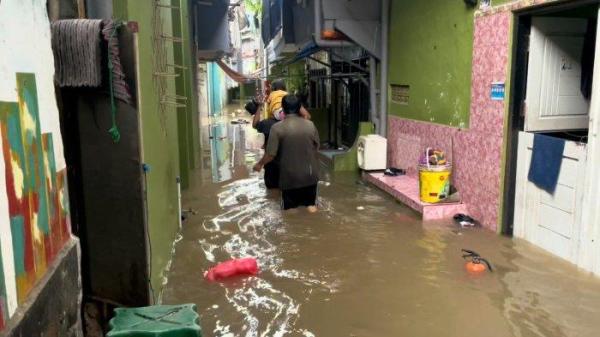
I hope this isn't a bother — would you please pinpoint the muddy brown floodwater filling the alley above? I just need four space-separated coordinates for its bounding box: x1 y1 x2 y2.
162 111 600 337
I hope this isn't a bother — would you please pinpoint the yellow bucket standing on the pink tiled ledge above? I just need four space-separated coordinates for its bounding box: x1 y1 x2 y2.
419 164 452 204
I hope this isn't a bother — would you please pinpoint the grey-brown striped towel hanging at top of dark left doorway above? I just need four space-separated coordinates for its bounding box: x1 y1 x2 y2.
52 19 102 87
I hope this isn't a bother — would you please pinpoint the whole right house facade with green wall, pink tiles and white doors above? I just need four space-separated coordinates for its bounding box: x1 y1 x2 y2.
386 0 599 273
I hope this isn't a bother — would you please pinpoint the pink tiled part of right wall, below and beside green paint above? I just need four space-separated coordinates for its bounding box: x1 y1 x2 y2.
388 11 512 230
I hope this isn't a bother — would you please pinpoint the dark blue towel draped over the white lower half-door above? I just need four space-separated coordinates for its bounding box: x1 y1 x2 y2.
527 134 565 194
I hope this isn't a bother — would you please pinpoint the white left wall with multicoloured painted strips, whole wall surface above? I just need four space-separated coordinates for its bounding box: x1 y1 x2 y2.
0 0 79 331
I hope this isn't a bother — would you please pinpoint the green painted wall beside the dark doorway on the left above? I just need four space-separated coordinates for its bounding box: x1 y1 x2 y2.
113 0 180 298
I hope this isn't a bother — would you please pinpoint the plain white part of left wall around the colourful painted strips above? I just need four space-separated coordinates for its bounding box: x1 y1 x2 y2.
0 0 66 316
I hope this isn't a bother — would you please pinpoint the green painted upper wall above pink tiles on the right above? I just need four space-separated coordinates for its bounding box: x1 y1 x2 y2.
387 0 474 128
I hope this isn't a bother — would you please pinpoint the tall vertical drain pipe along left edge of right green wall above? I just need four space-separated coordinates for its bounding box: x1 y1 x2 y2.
377 0 390 137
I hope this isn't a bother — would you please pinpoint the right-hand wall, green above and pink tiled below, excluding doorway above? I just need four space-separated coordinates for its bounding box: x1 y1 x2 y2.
388 0 568 230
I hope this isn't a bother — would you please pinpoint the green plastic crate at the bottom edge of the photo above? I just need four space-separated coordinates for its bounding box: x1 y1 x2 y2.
106 304 202 337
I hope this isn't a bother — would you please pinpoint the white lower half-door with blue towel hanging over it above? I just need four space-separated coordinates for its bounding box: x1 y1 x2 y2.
513 132 586 264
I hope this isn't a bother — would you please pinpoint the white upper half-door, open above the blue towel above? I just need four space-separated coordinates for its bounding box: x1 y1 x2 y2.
525 17 589 131
